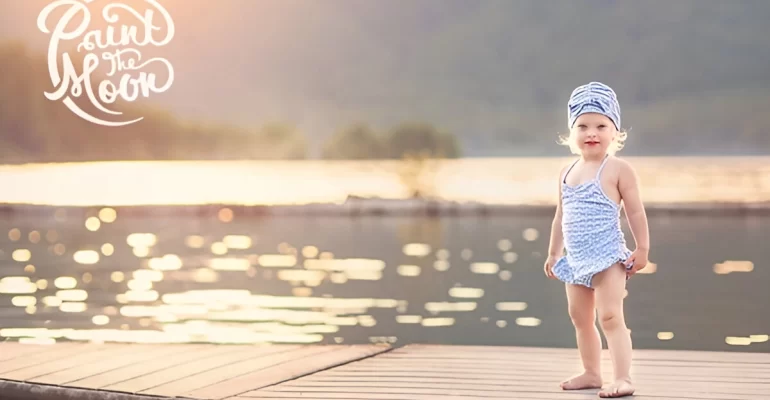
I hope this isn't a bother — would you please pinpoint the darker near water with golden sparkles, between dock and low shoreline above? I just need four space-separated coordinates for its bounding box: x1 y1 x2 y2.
0 208 770 351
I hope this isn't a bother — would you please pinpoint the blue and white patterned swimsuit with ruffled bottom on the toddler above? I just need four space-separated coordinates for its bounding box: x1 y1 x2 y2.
552 157 631 288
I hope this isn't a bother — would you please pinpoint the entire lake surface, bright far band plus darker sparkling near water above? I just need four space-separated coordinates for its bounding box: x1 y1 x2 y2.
0 157 770 352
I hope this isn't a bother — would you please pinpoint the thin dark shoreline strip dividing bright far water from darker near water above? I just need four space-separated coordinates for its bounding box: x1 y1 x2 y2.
0 199 770 218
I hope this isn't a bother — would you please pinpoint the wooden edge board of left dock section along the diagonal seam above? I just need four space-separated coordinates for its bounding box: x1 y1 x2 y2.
189 345 389 398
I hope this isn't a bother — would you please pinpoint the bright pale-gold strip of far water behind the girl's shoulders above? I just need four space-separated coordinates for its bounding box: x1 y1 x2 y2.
0 157 770 208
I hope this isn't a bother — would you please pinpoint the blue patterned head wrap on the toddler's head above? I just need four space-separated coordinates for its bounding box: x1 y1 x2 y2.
567 82 620 130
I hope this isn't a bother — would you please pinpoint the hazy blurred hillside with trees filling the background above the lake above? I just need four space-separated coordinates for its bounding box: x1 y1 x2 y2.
0 0 770 162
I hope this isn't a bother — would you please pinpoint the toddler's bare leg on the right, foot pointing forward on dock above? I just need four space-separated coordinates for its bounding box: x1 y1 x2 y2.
593 264 634 397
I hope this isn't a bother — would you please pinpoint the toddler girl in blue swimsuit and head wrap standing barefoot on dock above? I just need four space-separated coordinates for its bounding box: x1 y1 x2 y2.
545 82 650 397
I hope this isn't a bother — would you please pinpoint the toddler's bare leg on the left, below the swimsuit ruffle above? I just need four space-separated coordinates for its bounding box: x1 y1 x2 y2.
561 284 602 390
